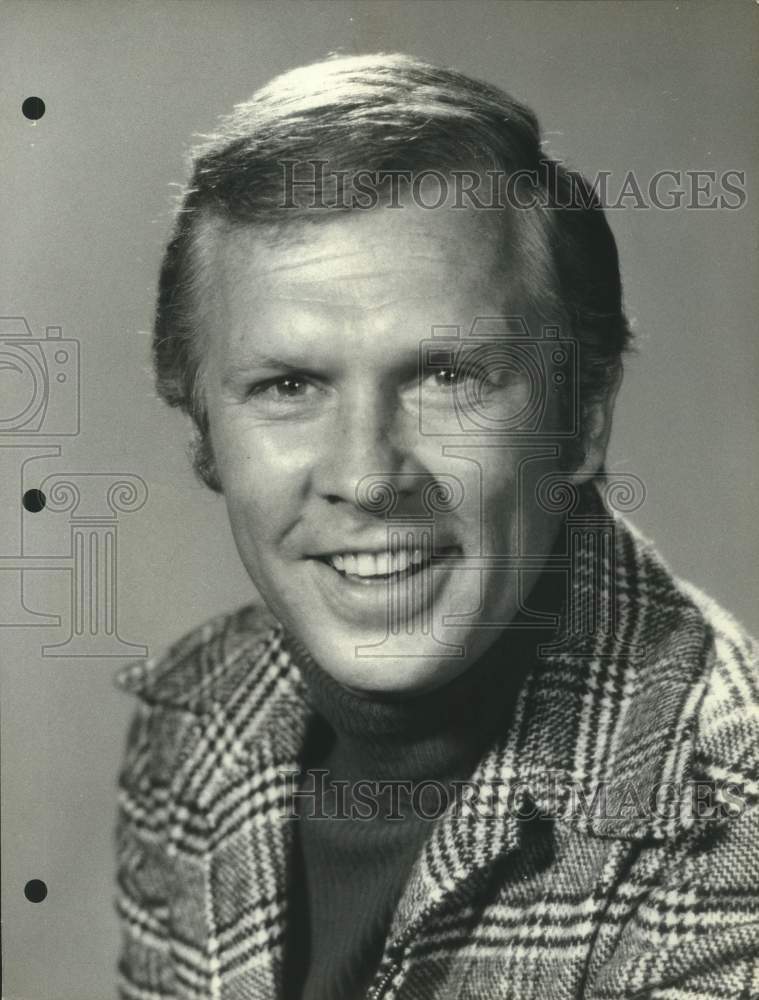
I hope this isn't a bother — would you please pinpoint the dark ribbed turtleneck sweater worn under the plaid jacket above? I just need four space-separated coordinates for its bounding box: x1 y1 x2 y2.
285 576 555 1000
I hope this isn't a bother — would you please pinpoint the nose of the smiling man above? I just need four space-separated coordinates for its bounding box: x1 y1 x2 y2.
314 391 418 509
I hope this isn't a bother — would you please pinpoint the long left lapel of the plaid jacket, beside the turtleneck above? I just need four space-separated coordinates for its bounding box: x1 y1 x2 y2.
169 628 314 1000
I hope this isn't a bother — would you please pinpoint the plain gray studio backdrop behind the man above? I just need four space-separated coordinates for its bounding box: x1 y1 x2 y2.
0 0 759 1000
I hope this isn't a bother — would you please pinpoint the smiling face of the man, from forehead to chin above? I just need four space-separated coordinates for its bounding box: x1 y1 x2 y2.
204 206 576 695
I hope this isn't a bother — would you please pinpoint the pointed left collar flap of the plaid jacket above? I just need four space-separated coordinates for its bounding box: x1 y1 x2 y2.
115 604 281 715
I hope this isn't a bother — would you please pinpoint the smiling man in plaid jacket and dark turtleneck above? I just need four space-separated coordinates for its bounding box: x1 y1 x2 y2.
118 56 759 1000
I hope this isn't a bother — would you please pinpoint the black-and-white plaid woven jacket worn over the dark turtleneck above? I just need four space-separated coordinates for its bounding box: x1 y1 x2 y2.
117 520 759 1000
